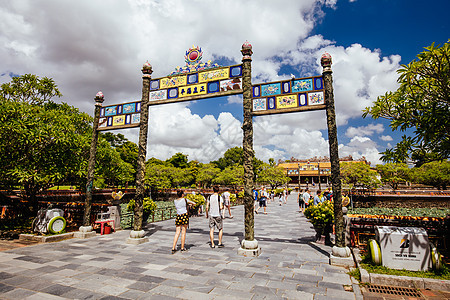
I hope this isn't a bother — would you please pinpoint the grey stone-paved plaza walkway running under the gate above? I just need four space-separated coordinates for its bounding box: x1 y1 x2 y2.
0 193 362 300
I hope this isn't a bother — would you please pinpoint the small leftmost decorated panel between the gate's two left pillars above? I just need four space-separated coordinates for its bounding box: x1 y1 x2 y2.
98 101 141 130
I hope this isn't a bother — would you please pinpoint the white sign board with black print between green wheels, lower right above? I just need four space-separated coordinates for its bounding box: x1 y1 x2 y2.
375 226 431 271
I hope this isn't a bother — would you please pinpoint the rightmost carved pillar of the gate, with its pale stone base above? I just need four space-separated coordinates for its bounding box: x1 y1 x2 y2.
321 53 350 257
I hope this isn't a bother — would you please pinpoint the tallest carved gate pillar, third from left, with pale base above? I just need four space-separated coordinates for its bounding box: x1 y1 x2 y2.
238 42 261 256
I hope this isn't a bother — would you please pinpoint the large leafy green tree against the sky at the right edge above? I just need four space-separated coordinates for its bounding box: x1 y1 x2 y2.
363 40 450 162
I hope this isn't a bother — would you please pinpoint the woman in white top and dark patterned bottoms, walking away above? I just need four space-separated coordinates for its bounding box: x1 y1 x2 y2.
172 190 195 254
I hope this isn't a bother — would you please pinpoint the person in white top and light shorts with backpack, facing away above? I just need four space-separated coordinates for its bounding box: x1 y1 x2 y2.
206 186 224 248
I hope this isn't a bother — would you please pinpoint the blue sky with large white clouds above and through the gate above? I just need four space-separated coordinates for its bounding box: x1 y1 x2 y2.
0 0 450 164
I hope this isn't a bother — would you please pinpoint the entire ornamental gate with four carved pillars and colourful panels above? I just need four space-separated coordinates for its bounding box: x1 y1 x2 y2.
83 42 345 255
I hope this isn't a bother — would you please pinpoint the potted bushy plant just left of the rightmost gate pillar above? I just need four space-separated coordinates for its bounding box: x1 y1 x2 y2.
304 201 334 244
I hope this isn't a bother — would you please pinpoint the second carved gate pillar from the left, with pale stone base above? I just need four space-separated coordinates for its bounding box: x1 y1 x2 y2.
127 62 153 244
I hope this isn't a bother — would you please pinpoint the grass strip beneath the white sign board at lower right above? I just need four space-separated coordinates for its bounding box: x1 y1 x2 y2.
360 255 450 280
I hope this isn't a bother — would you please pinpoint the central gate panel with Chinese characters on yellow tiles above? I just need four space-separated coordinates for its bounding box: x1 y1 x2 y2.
149 65 242 105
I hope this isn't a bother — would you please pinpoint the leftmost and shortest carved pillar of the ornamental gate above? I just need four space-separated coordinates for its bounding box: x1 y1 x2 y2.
80 91 105 227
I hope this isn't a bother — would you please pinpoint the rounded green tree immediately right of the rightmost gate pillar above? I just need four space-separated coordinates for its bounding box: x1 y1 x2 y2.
340 162 380 189
